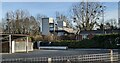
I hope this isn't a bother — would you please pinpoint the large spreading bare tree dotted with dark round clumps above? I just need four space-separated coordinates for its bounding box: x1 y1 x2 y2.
71 2 105 33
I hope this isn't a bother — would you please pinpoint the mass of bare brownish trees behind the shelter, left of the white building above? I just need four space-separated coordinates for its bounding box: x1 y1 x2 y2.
0 9 46 40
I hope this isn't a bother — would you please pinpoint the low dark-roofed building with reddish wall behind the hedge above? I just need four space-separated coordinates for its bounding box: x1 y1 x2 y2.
80 29 120 40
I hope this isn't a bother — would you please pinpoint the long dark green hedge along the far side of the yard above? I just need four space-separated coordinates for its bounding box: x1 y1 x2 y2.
51 34 120 49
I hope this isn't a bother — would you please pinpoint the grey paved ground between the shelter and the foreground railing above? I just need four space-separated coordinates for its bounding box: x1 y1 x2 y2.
2 49 118 59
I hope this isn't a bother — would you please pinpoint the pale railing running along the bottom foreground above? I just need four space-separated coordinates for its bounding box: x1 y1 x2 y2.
2 52 119 63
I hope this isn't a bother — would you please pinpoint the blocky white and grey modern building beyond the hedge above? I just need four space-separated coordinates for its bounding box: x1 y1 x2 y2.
42 18 73 36
